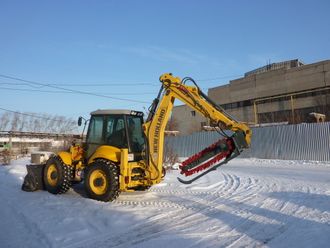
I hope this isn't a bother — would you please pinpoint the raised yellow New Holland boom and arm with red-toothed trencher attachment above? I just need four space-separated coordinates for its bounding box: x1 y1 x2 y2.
144 73 251 183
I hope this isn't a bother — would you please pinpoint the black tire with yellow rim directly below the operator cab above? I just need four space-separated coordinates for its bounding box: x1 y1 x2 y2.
84 160 119 202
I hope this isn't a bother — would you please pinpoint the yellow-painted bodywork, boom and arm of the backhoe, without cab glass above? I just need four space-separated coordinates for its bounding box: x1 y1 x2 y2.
45 74 252 200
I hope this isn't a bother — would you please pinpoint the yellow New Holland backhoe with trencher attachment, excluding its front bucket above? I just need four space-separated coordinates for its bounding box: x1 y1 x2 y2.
21 73 252 202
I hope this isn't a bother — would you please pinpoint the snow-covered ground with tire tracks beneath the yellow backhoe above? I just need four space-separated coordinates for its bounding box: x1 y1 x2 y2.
0 159 330 248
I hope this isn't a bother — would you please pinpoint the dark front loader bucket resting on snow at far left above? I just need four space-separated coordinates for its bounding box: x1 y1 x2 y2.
22 164 45 192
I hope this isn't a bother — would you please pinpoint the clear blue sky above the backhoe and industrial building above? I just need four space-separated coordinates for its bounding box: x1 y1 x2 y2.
0 0 330 119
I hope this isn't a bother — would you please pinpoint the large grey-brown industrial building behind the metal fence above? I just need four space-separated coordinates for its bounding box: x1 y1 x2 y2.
172 59 330 135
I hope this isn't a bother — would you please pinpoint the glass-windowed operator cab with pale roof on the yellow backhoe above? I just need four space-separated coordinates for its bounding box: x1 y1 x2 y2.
86 110 145 159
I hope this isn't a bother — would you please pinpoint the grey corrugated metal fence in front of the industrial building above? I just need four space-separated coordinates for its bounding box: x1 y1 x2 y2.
166 122 330 161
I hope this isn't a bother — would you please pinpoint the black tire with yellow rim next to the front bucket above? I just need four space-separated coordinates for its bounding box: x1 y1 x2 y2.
43 156 72 194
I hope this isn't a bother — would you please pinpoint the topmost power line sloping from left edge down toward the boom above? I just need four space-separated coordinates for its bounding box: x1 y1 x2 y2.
0 74 149 103
